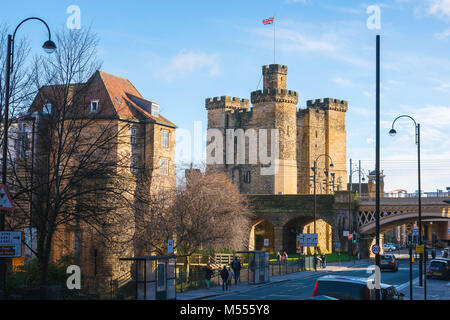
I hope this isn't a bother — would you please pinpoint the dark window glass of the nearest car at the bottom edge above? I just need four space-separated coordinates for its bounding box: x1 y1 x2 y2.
316 281 366 300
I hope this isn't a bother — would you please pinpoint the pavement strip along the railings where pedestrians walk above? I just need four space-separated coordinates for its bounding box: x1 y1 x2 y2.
176 259 373 300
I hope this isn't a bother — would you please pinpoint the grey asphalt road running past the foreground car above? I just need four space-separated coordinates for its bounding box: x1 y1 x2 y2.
209 260 419 300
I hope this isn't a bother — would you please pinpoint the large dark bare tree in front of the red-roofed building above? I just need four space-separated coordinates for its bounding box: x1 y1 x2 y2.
8 29 133 297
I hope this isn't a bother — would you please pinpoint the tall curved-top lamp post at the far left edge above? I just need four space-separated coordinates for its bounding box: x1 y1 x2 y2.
0 17 56 299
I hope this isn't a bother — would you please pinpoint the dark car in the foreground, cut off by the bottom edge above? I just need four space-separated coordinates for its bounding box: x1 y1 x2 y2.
312 276 404 300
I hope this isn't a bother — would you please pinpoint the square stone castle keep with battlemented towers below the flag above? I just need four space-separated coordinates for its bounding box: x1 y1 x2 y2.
206 64 348 194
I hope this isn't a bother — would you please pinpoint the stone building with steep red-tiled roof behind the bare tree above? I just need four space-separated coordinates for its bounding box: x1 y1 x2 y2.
10 71 176 292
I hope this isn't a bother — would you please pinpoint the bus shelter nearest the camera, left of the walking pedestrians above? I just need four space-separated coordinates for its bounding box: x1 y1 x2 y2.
119 256 177 300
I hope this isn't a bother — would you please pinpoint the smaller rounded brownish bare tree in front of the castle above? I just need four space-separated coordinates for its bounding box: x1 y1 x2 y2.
137 168 251 270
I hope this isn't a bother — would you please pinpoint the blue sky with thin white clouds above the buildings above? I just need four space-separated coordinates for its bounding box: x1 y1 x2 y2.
0 0 450 192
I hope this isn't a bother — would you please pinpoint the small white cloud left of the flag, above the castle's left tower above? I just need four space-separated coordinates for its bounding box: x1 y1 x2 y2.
155 50 220 81
